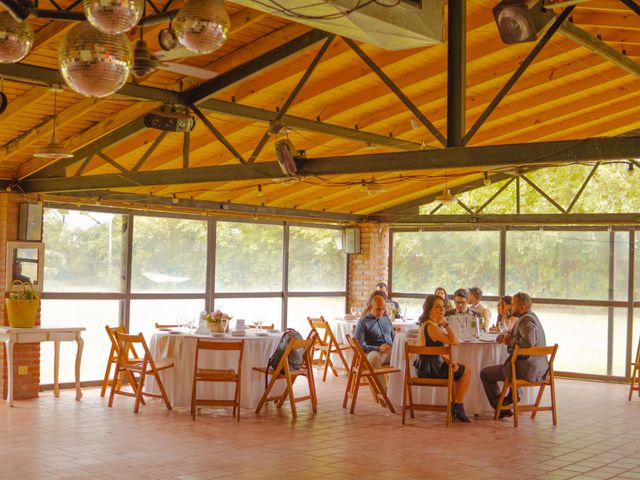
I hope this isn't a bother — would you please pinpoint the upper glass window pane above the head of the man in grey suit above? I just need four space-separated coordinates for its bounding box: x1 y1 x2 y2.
506 231 609 300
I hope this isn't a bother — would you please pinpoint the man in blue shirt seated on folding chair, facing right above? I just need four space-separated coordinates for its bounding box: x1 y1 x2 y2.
354 295 395 386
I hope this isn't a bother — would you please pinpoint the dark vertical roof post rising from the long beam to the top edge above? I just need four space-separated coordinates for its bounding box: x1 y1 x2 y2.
447 0 467 147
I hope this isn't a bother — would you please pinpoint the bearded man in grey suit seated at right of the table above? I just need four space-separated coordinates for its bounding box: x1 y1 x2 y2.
480 293 549 418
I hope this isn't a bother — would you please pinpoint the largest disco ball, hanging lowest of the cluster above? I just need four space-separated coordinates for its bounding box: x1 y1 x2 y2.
58 22 133 97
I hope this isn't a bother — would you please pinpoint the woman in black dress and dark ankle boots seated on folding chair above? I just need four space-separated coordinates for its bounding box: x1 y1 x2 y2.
414 295 471 422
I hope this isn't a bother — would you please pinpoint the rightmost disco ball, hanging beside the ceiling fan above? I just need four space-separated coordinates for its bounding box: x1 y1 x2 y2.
173 0 231 54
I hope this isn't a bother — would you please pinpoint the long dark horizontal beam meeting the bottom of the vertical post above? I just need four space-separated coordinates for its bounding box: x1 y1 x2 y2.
21 137 640 192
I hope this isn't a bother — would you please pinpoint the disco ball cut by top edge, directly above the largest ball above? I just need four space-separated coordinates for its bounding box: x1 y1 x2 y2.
84 0 144 35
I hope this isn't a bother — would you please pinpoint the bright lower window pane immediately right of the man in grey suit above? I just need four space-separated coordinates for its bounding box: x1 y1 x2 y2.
533 304 608 375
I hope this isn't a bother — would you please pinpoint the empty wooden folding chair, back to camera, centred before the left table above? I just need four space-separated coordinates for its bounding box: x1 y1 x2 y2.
191 338 244 422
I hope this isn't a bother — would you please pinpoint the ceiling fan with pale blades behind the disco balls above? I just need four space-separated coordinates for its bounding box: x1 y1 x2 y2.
132 28 219 80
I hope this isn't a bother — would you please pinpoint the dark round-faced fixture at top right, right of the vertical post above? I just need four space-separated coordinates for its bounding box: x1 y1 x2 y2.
493 0 555 44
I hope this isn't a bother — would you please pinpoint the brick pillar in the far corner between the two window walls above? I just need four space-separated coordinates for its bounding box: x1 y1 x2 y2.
349 223 389 305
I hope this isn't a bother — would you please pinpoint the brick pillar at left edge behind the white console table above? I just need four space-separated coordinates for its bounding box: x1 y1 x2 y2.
0 192 40 400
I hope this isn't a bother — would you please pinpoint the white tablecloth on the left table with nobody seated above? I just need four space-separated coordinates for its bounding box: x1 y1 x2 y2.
145 332 284 409
